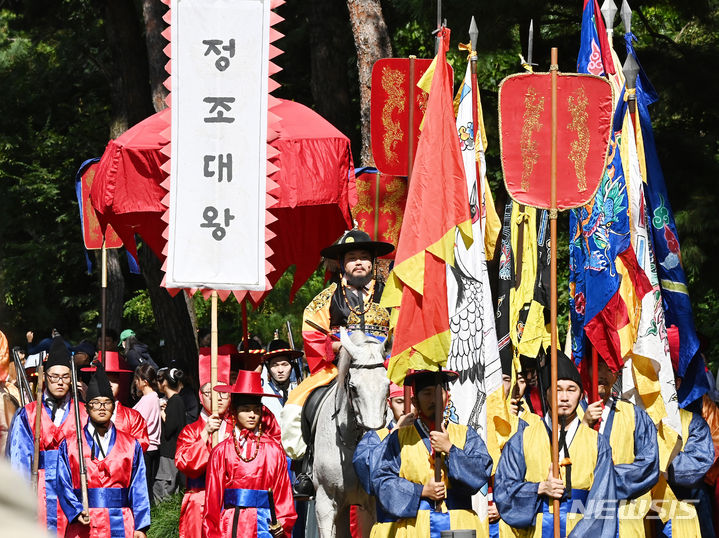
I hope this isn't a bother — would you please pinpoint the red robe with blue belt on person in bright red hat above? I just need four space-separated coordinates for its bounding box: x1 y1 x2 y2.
202 407 297 538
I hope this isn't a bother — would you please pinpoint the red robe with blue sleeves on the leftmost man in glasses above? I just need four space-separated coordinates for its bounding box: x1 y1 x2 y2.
7 395 87 536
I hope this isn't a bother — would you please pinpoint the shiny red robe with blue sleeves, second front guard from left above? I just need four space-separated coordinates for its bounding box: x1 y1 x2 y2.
57 420 150 538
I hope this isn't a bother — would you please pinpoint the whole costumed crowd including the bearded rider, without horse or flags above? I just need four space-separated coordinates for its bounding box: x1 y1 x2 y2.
0 230 719 538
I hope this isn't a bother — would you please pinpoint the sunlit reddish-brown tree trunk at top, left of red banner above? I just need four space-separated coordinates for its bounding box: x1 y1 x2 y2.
347 0 392 166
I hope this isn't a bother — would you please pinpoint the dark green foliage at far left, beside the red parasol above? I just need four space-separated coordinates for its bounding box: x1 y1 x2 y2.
0 6 108 341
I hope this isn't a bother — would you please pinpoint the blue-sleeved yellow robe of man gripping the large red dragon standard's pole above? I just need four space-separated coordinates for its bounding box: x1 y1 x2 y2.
494 421 617 538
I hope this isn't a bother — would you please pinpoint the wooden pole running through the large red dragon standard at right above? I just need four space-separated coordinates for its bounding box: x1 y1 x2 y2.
549 47 560 538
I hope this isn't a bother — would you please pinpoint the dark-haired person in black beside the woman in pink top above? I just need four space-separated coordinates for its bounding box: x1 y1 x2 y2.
152 368 185 502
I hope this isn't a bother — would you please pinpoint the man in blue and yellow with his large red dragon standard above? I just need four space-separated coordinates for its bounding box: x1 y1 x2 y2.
495 37 616 538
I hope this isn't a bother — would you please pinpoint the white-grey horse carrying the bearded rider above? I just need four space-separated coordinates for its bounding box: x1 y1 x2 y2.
313 328 389 538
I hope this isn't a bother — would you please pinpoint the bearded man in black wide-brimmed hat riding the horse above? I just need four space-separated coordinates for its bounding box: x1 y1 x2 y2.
280 229 394 495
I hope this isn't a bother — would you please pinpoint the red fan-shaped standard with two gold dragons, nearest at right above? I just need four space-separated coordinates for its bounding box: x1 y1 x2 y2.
499 73 612 210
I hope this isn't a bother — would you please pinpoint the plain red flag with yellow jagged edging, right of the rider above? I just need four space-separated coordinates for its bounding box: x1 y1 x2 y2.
382 28 472 385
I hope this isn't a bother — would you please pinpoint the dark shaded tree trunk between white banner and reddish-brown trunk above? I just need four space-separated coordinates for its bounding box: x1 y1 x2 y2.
310 0 354 140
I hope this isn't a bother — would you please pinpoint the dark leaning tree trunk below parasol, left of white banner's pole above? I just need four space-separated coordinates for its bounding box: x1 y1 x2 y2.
137 245 198 381
